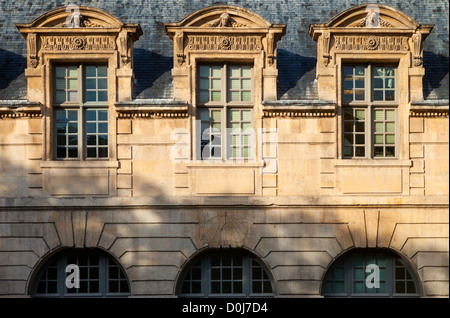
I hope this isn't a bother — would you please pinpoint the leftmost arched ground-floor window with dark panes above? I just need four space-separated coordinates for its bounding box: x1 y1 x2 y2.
31 248 130 297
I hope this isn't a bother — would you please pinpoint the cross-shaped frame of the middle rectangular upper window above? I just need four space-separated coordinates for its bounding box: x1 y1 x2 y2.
195 61 256 162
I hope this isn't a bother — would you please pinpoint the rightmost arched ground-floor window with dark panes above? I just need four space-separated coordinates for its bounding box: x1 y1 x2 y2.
322 248 420 297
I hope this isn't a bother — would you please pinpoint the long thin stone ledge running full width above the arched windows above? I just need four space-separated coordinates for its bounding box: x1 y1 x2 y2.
0 195 449 211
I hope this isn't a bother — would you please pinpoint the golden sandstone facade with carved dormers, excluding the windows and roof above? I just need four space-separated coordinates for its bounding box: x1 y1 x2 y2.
0 1 449 297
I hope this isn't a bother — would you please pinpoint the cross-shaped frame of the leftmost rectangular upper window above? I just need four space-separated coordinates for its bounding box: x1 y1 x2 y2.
50 60 111 161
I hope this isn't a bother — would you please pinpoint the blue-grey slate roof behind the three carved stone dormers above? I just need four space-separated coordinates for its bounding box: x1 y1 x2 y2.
0 0 449 100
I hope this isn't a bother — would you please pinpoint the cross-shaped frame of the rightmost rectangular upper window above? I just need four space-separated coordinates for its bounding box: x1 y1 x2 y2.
340 61 400 160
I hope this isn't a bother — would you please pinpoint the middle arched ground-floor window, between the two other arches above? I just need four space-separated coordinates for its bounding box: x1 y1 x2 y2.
176 249 275 297
